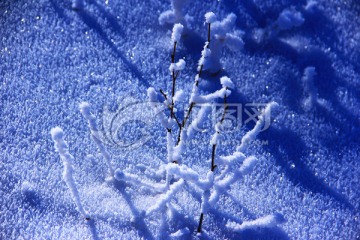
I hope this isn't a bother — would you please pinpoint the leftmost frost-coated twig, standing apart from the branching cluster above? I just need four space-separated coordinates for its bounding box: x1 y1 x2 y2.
51 127 90 219
